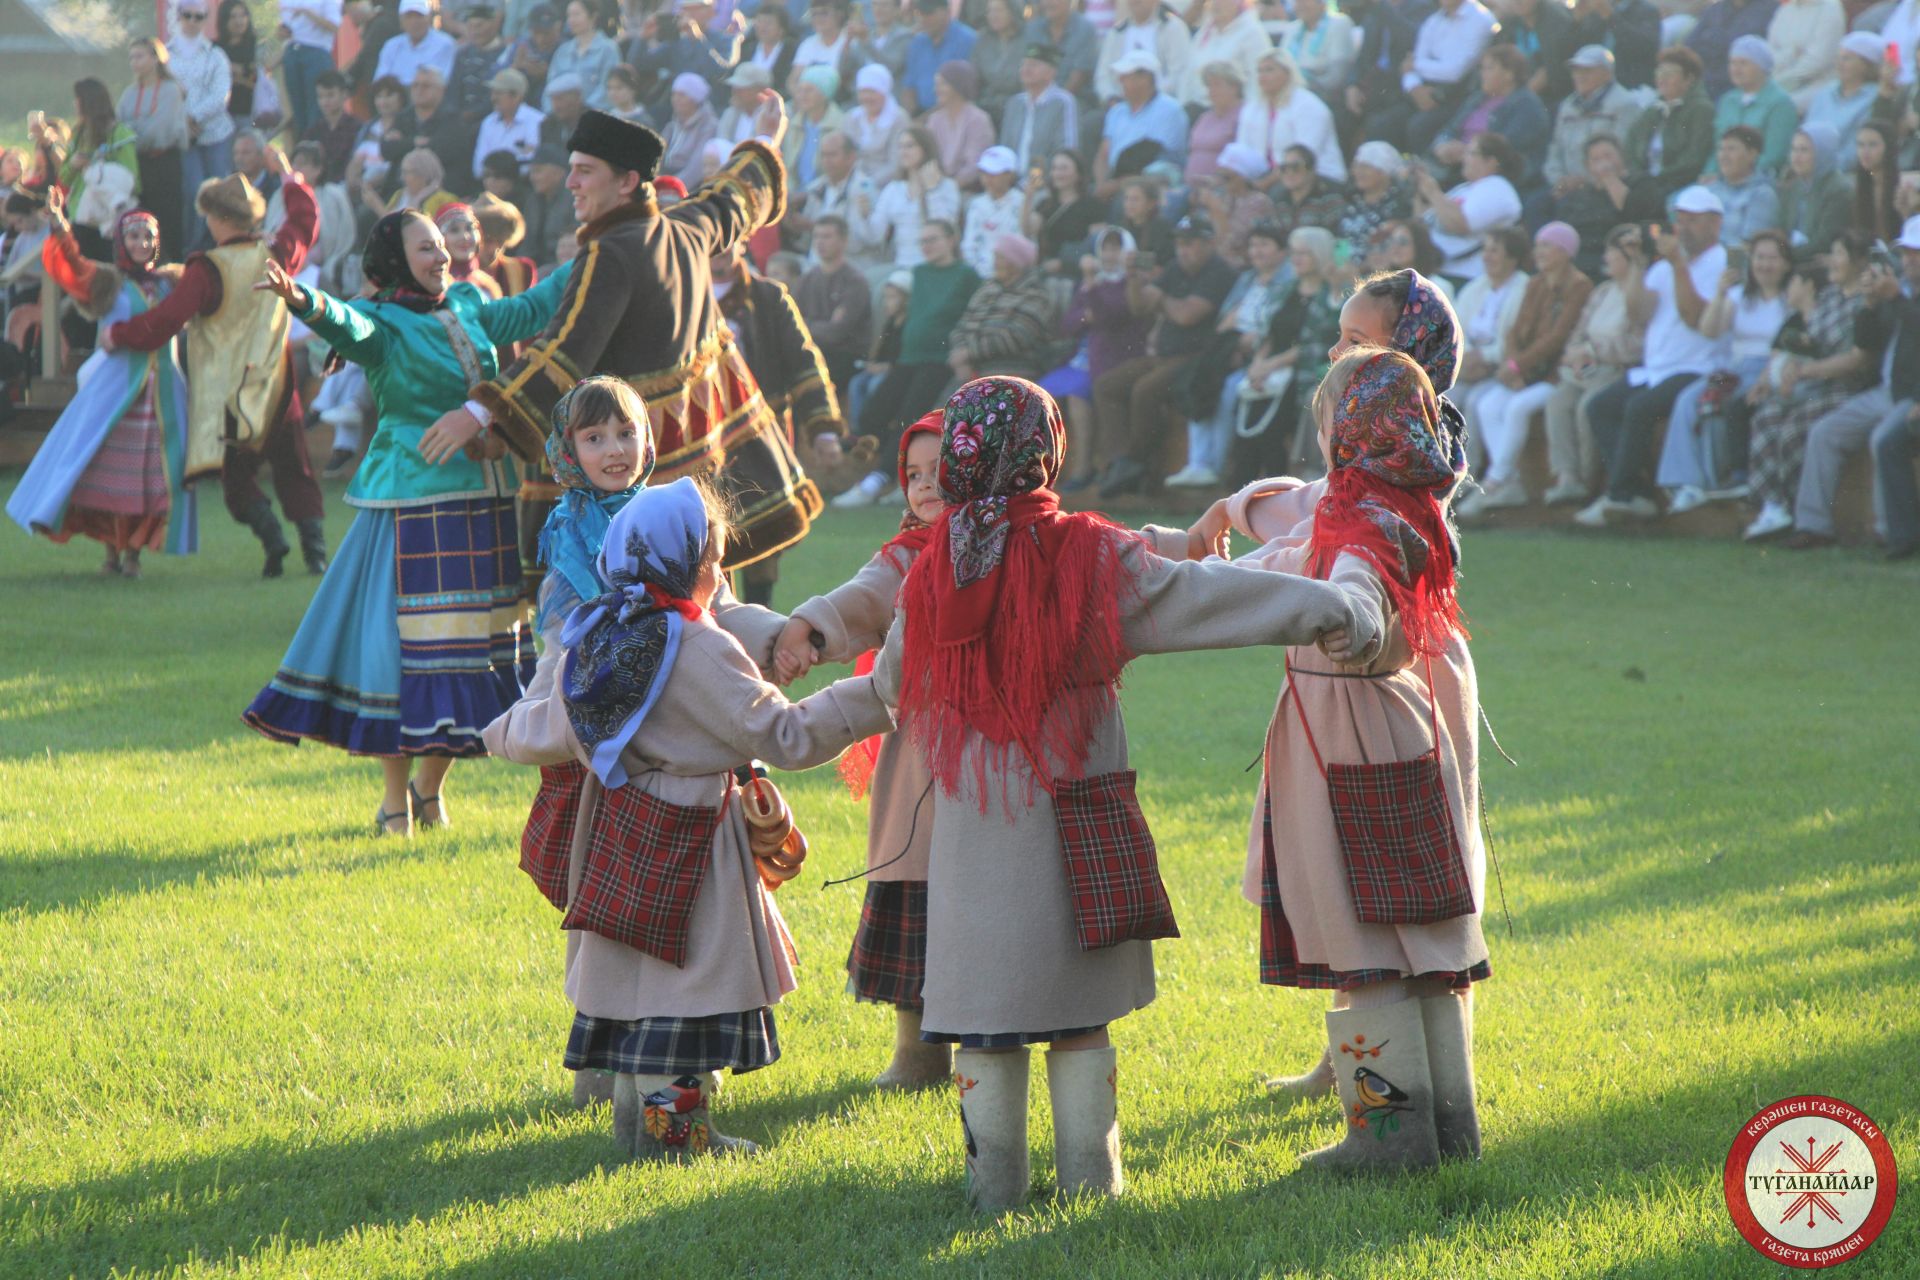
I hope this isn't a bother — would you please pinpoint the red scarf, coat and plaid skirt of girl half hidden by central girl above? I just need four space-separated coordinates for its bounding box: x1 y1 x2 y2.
793 409 952 1088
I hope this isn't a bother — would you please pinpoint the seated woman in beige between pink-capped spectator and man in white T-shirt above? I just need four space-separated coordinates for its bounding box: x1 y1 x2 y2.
1523 226 1647 507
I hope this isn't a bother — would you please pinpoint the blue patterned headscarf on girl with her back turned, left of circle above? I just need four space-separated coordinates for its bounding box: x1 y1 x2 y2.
561 480 707 787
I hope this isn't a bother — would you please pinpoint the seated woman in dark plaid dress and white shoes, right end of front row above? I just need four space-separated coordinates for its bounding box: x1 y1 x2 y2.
1745 232 1874 543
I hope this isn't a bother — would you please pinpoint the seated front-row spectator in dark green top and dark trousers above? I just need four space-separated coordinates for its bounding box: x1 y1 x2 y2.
833 219 979 507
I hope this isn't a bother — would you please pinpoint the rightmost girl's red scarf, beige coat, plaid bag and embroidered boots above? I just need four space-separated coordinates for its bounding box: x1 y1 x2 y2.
1242 351 1490 1167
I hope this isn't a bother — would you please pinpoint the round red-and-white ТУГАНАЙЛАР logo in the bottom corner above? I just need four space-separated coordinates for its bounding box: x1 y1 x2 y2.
1726 1094 1899 1268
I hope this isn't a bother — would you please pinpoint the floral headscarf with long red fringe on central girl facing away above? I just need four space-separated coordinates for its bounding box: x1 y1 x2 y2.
900 378 1129 808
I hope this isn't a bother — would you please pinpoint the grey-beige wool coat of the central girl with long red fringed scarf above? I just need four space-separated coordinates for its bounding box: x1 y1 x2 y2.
874 532 1365 1034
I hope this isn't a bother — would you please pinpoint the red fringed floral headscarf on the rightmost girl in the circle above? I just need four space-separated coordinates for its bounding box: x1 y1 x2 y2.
1311 351 1461 656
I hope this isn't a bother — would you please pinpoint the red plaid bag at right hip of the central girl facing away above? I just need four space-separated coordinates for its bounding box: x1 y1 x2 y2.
1054 770 1181 952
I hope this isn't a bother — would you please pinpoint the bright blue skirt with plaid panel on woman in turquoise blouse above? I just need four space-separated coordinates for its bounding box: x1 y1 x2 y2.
246 497 534 756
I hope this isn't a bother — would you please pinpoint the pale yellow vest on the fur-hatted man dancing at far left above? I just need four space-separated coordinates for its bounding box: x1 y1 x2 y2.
186 240 290 480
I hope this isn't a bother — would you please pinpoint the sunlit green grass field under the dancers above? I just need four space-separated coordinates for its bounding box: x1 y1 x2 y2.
0 482 1920 1280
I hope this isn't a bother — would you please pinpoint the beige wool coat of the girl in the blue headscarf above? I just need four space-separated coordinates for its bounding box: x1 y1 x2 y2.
484 581 893 1019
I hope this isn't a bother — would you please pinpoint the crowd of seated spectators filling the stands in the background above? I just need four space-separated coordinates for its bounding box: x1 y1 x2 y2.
0 0 1920 555
